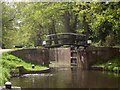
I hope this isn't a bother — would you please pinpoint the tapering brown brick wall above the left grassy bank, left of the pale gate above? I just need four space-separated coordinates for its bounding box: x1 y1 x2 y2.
11 49 49 66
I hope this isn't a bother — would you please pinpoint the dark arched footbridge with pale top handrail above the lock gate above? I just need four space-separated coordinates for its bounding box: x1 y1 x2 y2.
43 33 89 48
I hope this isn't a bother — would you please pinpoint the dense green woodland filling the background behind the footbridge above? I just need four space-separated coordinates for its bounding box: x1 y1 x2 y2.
1 2 120 48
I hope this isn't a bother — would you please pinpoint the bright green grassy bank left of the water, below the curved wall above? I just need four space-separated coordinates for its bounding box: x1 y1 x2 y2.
0 52 47 85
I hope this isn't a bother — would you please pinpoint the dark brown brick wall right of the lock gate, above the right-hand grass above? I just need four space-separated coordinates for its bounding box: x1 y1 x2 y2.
78 47 120 69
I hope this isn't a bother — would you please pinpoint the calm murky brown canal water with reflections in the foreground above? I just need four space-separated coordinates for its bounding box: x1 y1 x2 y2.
11 68 120 88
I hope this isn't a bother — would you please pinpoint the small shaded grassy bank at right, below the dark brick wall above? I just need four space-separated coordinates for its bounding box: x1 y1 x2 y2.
95 57 120 72
